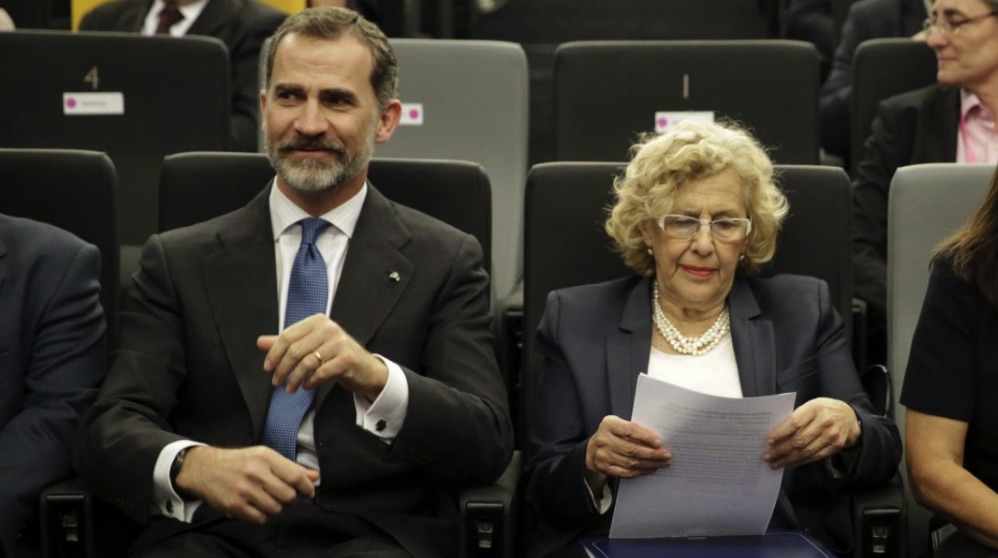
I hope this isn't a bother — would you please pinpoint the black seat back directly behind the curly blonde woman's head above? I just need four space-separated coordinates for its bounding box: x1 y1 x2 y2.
554 40 819 164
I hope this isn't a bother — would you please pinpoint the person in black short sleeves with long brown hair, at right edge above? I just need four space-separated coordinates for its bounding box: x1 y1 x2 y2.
901 167 998 558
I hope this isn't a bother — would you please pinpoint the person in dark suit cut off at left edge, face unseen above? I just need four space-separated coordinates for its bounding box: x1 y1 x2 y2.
0 215 106 557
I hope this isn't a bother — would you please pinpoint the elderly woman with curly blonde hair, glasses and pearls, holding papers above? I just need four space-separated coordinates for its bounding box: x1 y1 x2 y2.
525 121 901 556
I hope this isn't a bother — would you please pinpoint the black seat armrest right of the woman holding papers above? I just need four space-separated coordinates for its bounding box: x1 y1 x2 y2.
852 475 908 558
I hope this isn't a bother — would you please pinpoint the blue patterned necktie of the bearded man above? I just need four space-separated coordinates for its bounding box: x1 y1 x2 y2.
263 217 330 461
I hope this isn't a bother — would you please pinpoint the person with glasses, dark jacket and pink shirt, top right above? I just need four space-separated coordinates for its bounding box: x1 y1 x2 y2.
853 0 998 372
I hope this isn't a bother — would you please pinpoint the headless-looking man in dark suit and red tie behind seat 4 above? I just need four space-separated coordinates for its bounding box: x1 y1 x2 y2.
80 0 286 151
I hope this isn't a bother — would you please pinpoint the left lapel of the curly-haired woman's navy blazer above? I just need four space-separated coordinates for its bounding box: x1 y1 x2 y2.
606 278 651 420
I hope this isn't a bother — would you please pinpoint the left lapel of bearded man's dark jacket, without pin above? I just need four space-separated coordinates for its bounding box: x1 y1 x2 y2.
202 186 280 435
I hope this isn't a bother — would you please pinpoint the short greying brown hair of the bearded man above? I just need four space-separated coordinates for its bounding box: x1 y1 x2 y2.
265 7 398 108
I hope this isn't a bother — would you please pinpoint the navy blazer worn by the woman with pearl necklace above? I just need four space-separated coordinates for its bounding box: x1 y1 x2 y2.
525 275 901 556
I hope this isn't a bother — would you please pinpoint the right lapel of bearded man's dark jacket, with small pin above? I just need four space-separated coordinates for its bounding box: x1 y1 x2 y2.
315 186 413 408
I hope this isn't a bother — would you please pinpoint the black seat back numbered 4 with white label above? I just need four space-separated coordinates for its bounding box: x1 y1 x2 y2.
0 31 230 304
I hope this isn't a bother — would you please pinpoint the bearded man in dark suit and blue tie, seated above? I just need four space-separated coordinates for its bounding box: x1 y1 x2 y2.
76 8 512 557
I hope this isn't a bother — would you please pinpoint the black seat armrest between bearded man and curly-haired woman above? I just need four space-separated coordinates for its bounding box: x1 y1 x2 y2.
459 451 523 558
